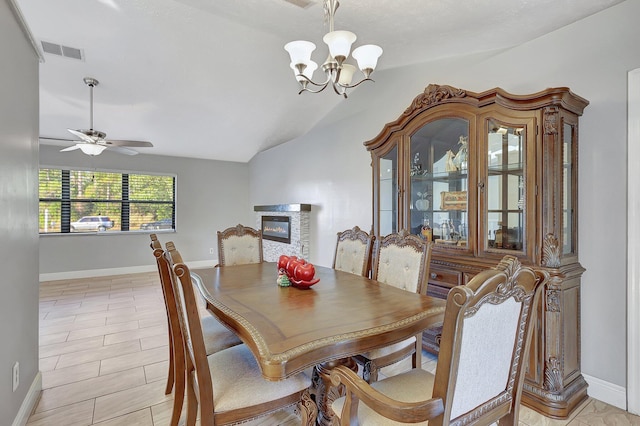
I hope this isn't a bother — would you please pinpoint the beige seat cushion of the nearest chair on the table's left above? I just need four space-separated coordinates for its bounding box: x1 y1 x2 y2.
207 345 311 412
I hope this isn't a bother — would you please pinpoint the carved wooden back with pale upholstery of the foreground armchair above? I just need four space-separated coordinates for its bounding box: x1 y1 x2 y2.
433 256 548 424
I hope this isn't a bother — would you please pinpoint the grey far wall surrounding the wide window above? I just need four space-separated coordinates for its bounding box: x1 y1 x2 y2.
40 145 255 279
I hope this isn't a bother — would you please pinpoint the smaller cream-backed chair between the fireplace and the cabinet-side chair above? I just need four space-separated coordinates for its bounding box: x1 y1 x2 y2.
333 226 375 277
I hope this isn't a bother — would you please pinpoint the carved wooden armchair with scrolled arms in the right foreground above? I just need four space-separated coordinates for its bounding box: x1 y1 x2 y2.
330 256 549 426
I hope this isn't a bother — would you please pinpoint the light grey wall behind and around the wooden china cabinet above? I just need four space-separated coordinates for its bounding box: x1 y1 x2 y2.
250 0 640 400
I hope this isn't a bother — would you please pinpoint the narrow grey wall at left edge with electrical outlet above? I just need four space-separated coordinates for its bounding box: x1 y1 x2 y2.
0 1 39 425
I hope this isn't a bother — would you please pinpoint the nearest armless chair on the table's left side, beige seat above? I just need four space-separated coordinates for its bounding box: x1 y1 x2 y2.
165 242 318 426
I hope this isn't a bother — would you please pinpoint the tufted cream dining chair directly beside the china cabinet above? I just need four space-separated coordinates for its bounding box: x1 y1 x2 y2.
354 230 432 383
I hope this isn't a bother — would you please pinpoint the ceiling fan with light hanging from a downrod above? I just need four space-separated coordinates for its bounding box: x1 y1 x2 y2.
41 77 153 155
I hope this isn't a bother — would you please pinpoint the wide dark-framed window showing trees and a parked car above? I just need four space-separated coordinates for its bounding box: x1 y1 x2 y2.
39 168 176 234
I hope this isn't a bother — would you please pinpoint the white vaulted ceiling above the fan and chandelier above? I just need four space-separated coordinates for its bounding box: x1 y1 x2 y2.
14 0 622 162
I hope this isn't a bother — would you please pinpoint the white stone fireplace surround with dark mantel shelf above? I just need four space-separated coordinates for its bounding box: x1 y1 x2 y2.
253 204 311 262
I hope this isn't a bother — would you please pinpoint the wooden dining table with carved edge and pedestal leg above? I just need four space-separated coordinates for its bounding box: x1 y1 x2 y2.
191 262 445 424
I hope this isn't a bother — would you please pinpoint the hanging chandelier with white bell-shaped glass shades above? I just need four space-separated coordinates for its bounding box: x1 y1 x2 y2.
284 0 382 98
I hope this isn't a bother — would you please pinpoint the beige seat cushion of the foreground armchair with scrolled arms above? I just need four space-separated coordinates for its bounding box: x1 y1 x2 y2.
331 368 435 426
